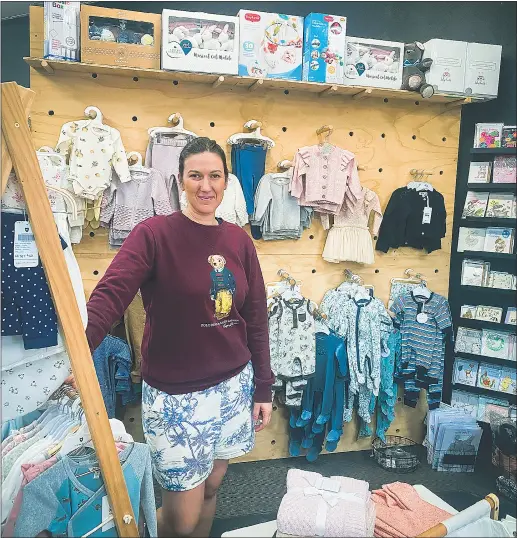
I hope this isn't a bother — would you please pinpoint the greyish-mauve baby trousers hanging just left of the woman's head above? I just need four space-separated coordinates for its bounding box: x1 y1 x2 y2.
145 132 196 211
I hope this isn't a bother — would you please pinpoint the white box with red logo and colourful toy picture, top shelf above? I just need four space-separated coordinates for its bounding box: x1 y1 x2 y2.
239 9 303 80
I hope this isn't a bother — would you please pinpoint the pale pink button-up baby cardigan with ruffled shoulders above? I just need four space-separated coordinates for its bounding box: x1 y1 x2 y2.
289 145 362 215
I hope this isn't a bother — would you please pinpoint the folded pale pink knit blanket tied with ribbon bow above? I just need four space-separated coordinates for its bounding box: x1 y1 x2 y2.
277 469 375 538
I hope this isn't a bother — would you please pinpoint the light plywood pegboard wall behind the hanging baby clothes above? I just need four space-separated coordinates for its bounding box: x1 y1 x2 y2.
27 9 461 461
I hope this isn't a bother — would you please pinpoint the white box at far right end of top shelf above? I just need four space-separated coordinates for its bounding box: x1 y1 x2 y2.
465 43 502 97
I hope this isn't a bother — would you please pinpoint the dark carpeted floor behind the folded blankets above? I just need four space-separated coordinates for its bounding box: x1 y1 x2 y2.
211 452 516 537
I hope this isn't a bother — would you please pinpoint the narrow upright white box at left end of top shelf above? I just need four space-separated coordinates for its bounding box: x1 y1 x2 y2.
43 2 81 62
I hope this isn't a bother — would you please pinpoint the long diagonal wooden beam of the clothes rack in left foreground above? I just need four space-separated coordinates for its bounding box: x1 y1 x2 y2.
1 82 138 537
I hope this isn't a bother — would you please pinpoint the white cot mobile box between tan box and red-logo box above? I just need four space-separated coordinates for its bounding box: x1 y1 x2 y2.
162 9 239 75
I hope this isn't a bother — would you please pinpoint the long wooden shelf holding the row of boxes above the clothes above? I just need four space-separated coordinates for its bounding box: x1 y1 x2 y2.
24 57 489 105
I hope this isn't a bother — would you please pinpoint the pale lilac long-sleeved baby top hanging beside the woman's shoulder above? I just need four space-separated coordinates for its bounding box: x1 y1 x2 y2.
100 168 172 247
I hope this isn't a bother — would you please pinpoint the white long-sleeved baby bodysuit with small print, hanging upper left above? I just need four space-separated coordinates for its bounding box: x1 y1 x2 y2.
56 119 131 200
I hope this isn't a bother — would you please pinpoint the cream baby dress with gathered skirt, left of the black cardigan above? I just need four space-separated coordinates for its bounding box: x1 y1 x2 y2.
321 187 382 264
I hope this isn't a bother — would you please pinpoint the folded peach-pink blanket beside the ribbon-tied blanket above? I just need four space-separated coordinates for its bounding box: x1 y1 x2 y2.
372 482 451 538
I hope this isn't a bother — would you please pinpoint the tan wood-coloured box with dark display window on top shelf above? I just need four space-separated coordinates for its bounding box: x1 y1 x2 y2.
81 5 161 69
